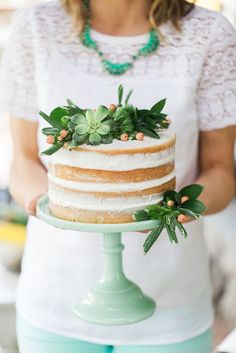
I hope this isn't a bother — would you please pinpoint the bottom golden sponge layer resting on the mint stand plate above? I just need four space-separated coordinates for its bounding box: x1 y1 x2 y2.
49 202 134 224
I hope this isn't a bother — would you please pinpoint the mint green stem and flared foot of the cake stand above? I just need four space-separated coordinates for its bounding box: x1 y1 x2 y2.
74 233 156 325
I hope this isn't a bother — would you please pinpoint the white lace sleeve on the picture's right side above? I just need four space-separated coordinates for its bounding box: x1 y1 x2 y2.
197 15 236 131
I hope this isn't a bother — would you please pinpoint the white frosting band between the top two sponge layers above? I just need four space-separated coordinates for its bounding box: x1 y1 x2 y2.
50 146 175 171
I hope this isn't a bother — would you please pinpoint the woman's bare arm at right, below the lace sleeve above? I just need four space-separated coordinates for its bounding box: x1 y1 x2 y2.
196 126 236 214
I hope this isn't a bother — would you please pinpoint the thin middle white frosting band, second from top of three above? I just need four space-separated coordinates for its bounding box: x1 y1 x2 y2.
48 171 175 192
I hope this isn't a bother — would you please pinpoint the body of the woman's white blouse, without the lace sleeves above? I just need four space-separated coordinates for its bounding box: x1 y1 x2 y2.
17 2 214 344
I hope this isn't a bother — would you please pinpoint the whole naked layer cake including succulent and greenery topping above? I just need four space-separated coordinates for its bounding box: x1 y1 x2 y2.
41 88 175 223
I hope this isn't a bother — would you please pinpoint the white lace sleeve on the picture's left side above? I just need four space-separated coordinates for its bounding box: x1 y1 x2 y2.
0 9 38 121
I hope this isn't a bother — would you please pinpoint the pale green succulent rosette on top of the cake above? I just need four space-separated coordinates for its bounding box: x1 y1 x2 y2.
71 105 112 145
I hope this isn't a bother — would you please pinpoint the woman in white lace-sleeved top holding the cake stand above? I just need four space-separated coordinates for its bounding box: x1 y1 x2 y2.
2 0 236 353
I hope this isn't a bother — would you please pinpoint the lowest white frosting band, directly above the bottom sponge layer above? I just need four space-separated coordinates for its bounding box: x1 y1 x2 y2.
48 187 162 212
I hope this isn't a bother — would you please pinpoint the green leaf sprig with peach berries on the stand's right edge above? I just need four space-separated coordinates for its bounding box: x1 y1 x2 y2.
133 184 206 254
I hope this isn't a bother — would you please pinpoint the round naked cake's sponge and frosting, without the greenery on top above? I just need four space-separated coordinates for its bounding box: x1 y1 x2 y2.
48 132 175 223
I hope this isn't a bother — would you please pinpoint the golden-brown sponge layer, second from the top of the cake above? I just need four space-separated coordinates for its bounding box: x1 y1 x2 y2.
49 163 174 183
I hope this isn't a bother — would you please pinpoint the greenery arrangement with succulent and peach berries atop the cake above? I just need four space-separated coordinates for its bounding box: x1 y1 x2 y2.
39 85 170 155
